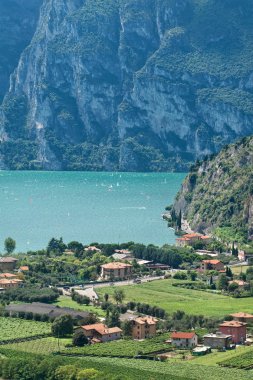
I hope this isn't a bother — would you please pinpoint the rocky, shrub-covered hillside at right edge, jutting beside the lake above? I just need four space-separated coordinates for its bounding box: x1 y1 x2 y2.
173 137 253 241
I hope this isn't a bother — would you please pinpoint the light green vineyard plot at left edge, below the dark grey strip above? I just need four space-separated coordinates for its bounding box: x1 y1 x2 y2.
0 317 51 340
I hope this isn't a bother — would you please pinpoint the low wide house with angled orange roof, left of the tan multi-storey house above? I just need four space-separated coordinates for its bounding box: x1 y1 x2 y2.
81 323 122 343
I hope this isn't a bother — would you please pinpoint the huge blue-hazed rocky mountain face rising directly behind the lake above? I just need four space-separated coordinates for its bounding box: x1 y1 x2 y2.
0 0 253 171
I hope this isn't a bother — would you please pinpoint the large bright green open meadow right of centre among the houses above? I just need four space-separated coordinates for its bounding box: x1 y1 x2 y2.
97 280 253 317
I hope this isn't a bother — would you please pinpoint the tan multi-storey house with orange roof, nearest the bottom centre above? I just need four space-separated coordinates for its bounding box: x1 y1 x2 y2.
132 317 158 339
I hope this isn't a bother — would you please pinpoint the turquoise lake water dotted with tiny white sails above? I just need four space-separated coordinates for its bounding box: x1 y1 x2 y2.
0 171 185 251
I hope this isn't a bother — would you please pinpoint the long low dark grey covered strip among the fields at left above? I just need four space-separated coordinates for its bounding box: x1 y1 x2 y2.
4 302 90 320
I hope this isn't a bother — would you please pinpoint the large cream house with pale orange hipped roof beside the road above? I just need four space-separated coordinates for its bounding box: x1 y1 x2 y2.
101 262 132 280
